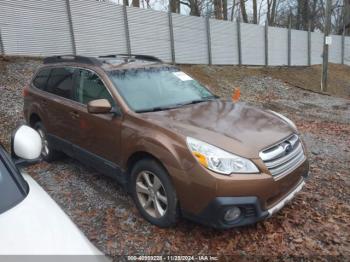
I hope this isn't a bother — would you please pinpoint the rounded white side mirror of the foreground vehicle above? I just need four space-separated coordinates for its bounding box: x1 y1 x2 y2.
11 125 42 164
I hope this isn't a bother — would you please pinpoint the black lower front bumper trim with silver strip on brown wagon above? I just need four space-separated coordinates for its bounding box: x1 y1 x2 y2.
184 178 305 229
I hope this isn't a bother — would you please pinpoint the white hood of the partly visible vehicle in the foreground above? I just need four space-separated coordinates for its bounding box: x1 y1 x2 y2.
0 174 107 256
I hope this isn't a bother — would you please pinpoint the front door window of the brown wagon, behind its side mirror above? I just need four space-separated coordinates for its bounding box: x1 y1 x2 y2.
75 69 115 106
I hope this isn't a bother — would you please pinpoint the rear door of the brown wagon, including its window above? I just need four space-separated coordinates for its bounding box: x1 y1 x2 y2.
42 66 79 154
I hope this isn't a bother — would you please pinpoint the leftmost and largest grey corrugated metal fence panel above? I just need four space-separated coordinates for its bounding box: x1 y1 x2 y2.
0 0 72 56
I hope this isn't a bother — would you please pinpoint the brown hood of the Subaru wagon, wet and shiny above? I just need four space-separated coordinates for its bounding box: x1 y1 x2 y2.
144 99 294 158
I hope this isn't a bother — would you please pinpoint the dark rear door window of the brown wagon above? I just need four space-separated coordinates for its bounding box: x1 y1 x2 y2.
47 67 75 99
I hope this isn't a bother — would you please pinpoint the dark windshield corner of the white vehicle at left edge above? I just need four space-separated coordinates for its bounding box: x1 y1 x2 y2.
0 145 28 214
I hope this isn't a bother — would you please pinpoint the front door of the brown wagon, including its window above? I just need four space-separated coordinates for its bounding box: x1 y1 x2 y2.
70 69 122 173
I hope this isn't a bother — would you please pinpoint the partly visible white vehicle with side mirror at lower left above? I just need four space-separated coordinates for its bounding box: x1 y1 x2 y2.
0 125 105 261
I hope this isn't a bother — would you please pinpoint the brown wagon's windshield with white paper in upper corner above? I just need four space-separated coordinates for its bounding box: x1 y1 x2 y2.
111 67 217 112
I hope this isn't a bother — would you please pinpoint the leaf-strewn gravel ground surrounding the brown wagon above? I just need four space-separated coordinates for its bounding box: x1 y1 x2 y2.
0 59 350 260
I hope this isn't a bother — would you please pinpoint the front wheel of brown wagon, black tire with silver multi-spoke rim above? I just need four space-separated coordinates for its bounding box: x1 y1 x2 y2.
129 159 179 228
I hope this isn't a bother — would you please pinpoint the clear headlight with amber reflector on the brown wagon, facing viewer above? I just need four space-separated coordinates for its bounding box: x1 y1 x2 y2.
187 137 259 175
